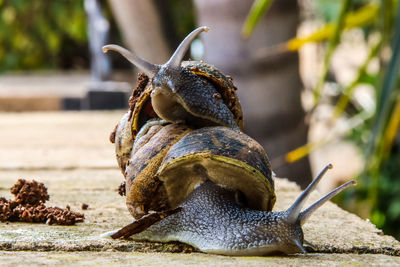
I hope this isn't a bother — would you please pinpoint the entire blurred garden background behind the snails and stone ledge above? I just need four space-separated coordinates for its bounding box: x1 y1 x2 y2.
0 0 400 239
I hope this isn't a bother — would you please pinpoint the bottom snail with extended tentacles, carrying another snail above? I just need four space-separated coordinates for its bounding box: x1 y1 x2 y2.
111 118 355 256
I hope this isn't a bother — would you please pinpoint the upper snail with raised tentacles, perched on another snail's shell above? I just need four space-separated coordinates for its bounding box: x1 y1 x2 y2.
107 27 243 173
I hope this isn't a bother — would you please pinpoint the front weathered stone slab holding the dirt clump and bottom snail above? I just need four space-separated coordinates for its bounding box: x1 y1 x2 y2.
0 169 400 255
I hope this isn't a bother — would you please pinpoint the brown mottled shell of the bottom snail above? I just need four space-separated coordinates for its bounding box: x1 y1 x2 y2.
125 124 276 219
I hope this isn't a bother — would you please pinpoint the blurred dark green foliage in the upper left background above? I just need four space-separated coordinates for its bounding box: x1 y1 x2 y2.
0 0 195 72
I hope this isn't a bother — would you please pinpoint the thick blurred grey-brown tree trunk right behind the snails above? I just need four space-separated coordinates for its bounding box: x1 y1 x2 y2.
195 0 311 187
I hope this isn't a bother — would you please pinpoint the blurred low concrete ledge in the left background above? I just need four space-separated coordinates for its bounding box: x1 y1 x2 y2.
0 70 136 112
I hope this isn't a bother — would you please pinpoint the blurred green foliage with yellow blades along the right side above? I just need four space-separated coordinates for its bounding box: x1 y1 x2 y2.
249 0 400 240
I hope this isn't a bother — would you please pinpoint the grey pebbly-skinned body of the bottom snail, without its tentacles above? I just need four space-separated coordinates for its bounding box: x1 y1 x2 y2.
132 181 305 256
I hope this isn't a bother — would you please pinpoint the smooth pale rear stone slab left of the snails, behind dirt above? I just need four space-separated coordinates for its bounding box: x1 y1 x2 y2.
0 111 119 170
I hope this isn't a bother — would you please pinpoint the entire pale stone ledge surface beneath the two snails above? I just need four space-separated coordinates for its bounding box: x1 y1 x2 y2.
0 111 400 266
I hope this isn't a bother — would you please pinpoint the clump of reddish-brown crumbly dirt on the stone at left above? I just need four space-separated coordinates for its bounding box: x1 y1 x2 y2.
0 179 85 225
